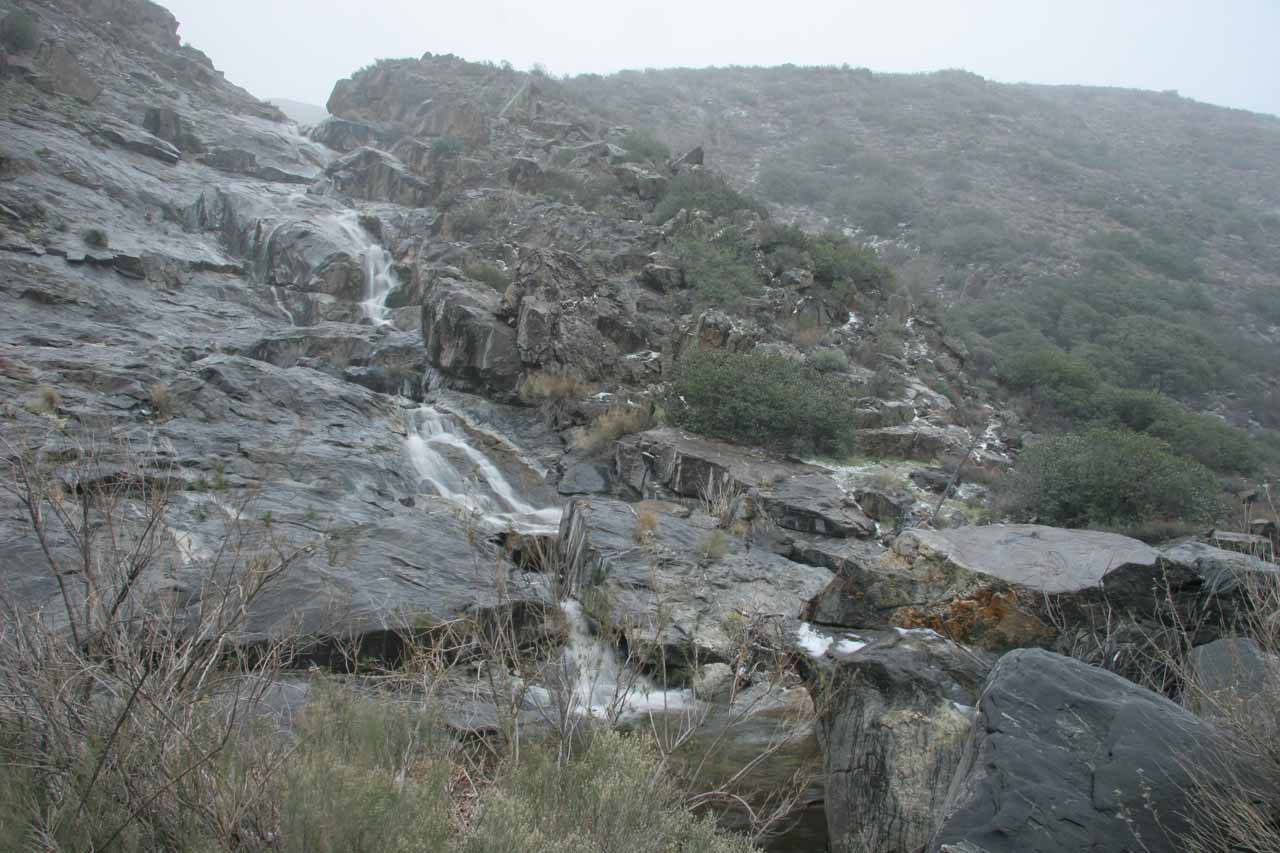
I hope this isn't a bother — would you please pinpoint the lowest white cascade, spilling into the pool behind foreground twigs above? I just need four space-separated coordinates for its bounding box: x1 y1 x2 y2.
561 598 694 720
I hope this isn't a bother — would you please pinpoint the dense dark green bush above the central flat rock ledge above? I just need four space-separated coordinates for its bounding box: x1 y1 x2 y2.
666 351 854 456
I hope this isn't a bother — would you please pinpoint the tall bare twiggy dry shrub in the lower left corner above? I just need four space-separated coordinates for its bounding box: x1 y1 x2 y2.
0 442 300 850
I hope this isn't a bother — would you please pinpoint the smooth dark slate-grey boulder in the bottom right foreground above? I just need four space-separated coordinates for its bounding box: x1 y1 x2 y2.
928 649 1215 853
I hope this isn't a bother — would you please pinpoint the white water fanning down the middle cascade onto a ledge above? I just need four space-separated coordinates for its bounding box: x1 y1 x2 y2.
404 406 561 533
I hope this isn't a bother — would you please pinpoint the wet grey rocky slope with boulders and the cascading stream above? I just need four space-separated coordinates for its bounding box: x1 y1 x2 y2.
0 0 1274 850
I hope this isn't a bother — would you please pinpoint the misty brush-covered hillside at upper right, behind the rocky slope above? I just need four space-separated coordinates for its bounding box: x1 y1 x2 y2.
563 67 1280 427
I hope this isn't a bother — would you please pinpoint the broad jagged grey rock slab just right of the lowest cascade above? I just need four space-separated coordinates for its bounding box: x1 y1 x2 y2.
557 497 828 680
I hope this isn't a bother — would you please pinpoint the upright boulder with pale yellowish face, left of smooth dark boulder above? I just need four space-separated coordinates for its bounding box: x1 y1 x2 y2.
803 631 992 853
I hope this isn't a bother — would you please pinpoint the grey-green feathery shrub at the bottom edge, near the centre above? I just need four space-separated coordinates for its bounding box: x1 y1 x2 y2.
458 730 753 853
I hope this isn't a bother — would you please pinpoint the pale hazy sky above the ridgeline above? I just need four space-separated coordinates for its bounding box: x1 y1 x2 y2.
160 0 1280 114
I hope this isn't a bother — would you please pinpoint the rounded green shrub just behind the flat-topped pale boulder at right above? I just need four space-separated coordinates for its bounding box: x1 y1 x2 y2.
1011 427 1219 528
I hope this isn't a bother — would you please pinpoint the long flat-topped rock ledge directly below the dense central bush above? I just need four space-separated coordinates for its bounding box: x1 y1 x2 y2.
614 428 876 537
